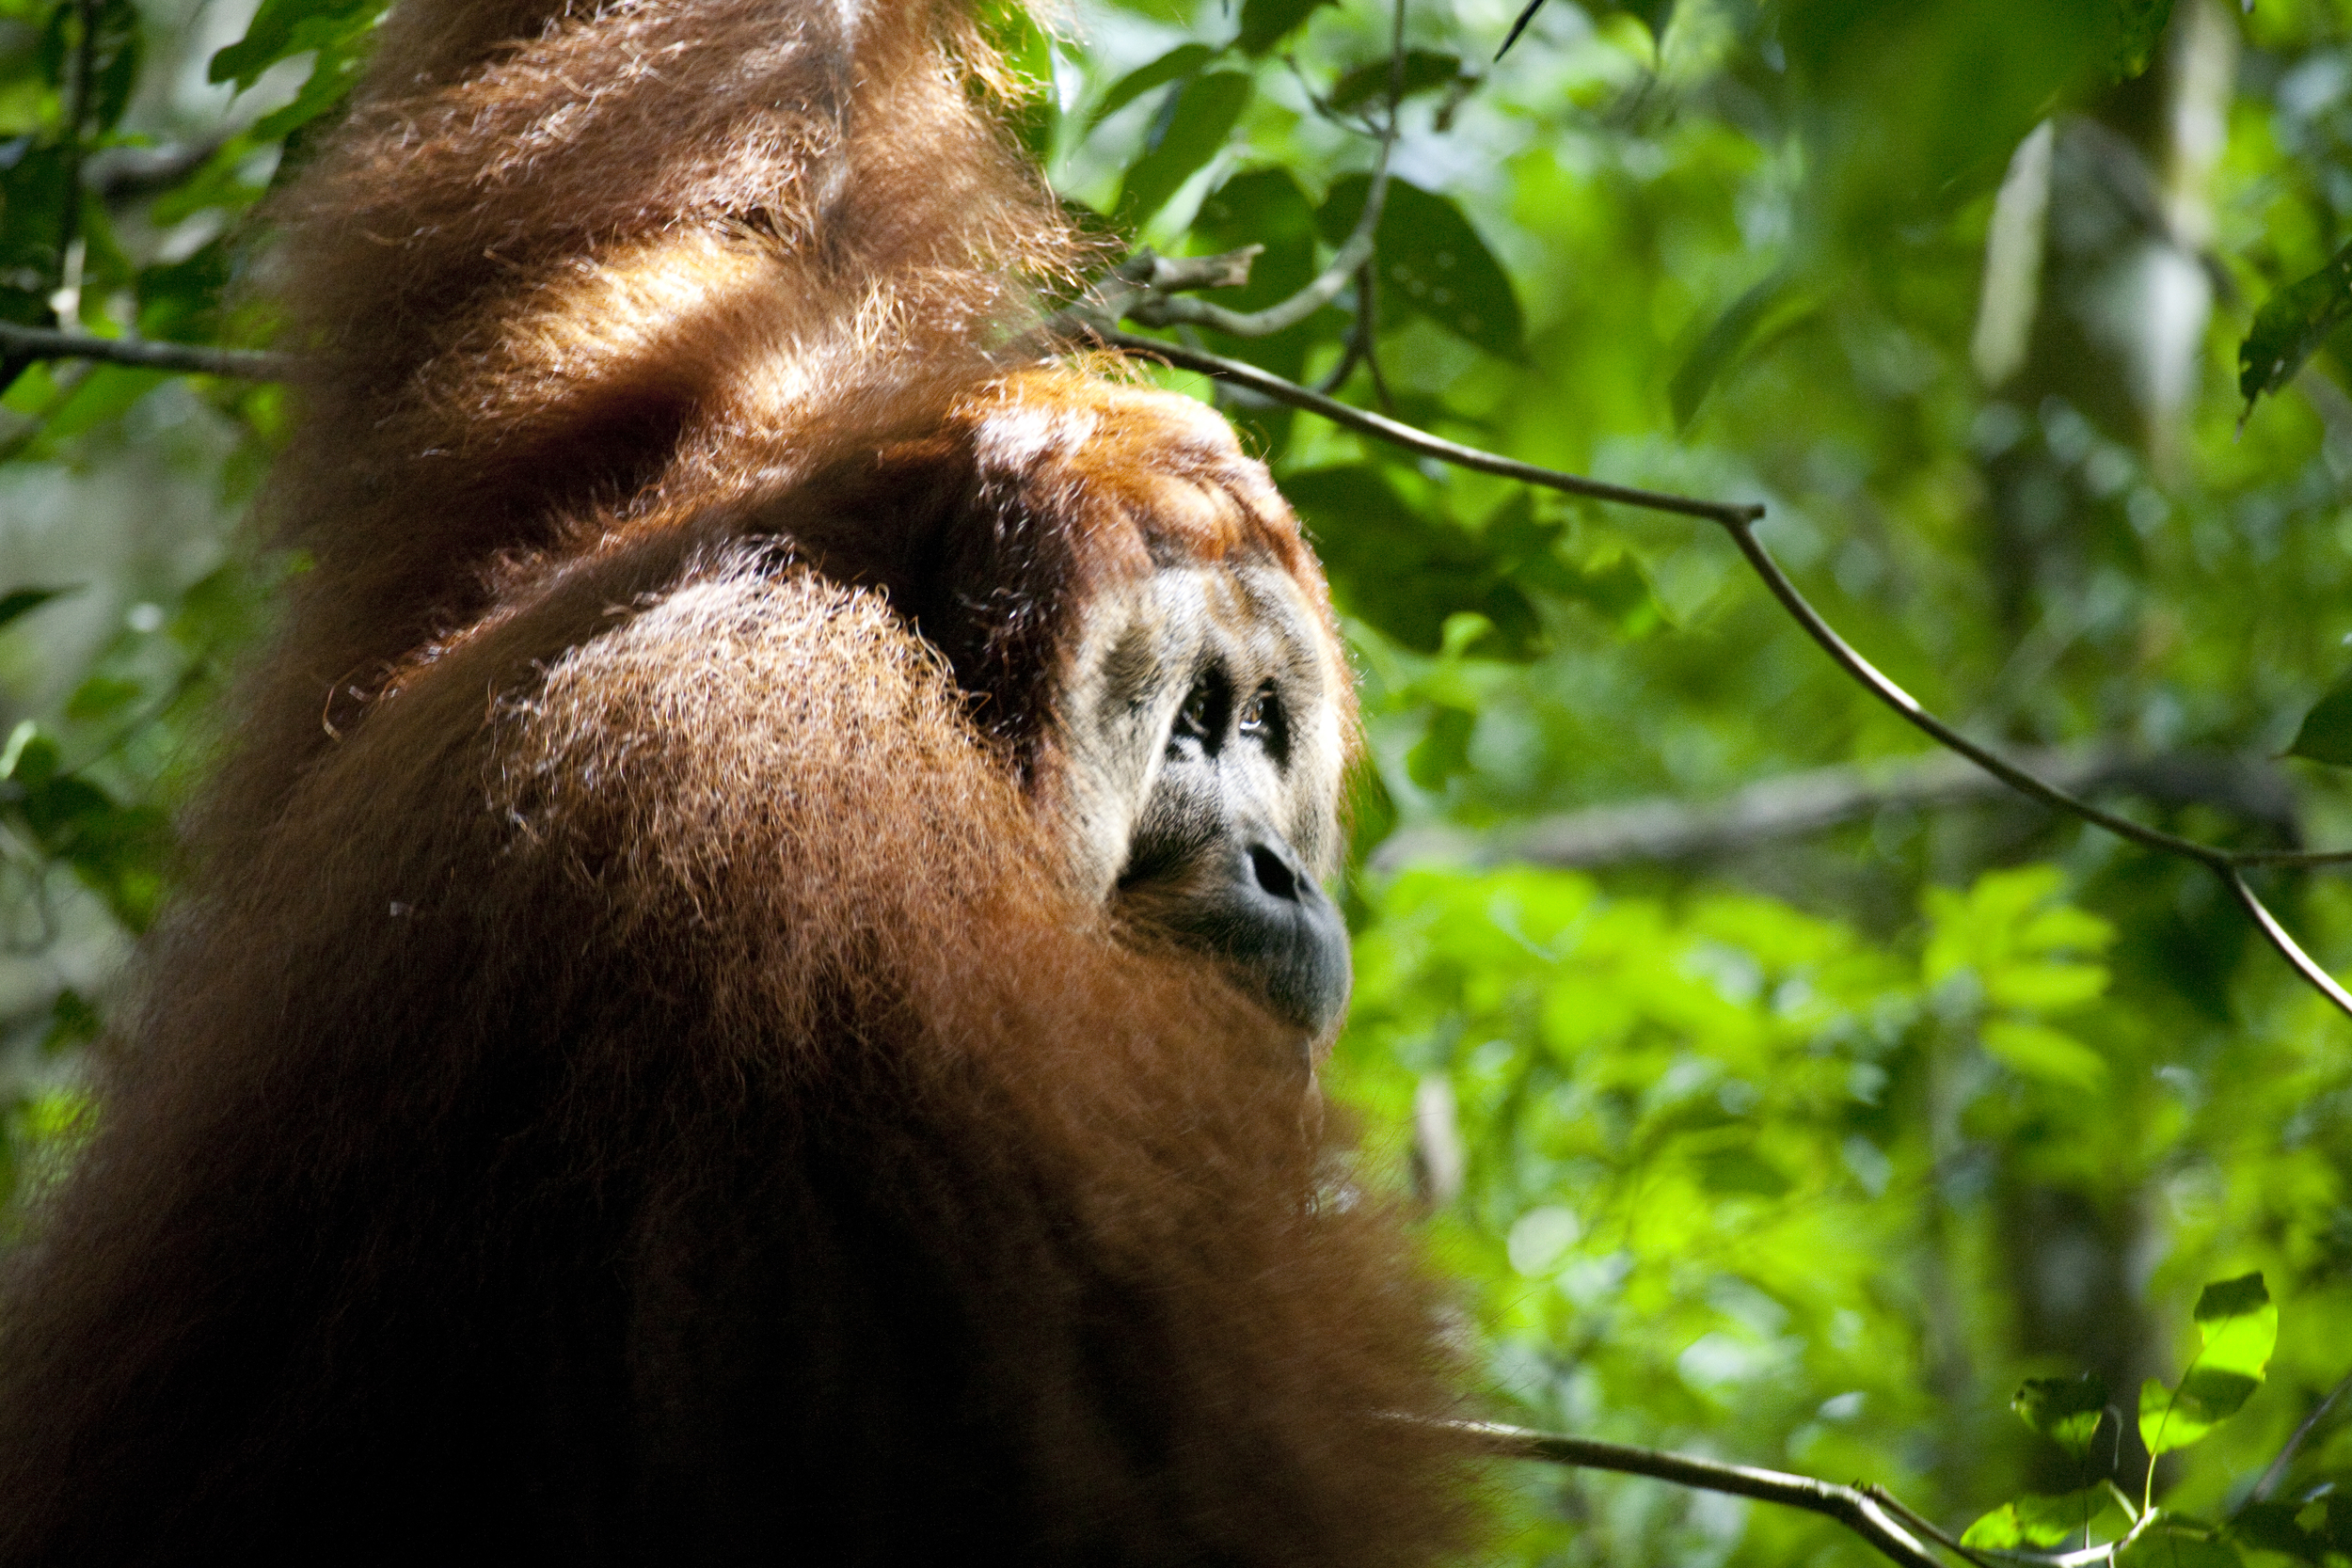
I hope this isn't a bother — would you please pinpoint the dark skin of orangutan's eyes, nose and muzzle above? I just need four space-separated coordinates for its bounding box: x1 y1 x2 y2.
1118 663 1350 1041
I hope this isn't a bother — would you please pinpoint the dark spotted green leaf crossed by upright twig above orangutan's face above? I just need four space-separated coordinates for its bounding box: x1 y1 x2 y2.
1315 174 1522 359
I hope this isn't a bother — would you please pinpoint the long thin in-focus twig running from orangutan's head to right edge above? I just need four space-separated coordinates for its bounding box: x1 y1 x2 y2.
1099 331 2352 1018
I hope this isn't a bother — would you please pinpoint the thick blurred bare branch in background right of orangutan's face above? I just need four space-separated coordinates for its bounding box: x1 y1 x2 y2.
1372 748 2294 870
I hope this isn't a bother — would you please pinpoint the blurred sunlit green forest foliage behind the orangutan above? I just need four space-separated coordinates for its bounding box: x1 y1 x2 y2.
0 0 2352 1568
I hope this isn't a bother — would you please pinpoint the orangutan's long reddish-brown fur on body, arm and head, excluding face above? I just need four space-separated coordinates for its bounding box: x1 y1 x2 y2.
0 0 1458 1566
